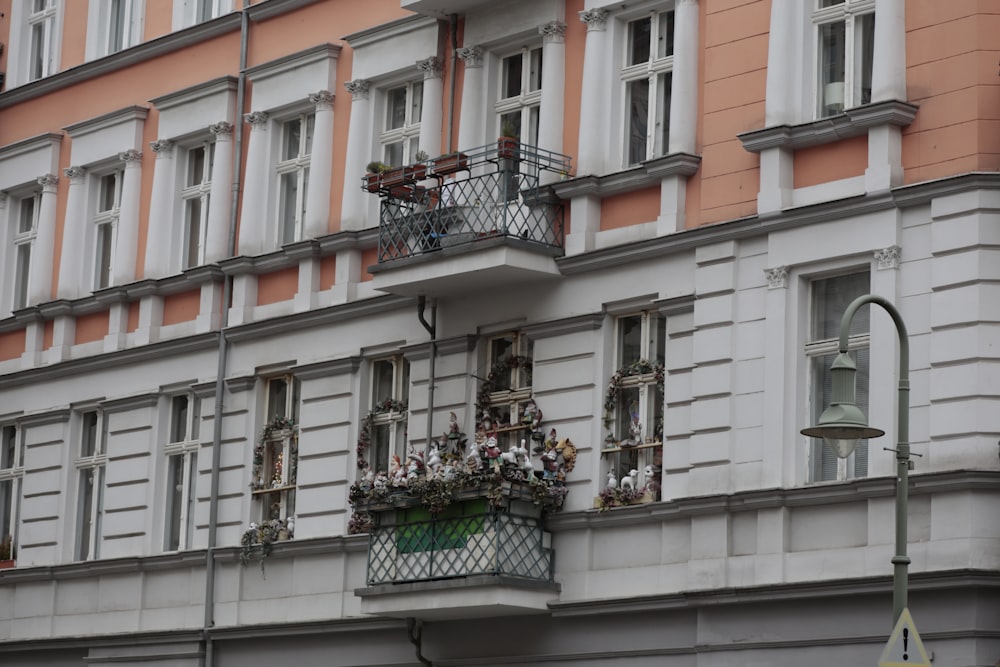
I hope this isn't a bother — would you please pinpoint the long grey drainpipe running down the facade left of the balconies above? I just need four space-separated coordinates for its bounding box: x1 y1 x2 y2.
201 5 250 667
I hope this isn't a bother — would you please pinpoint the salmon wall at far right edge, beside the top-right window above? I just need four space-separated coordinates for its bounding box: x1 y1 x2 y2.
903 0 1000 183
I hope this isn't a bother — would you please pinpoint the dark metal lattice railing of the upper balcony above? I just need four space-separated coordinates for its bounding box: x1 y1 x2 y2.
364 144 570 263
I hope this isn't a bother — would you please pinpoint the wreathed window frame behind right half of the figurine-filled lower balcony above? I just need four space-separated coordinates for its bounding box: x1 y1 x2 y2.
476 331 534 451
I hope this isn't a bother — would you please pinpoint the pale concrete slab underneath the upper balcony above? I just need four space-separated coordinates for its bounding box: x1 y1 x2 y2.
368 236 563 297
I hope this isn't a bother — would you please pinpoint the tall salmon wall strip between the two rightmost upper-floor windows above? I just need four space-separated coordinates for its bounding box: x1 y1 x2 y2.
686 0 771 227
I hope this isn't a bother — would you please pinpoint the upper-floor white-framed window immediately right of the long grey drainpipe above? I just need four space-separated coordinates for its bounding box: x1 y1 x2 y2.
274 111 316 246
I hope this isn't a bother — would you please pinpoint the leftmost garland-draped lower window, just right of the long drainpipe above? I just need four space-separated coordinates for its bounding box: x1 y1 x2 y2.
251 375 301 522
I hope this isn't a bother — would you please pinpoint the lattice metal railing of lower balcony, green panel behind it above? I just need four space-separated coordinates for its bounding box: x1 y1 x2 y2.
368 509 552 585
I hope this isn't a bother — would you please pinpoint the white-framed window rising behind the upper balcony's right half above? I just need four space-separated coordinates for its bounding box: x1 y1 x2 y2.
496 47 542 146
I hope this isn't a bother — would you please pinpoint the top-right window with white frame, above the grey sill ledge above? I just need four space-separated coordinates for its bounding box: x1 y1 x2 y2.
813 0 875 118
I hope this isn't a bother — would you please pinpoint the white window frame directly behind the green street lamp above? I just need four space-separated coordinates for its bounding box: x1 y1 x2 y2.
803 270 871 482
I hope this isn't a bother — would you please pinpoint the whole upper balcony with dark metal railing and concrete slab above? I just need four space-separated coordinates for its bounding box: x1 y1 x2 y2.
363 138 570 296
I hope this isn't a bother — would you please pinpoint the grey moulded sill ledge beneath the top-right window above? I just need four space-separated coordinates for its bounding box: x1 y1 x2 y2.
737 100 918 153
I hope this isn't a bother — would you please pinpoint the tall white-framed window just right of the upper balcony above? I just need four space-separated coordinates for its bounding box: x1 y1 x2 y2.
621 11 674 165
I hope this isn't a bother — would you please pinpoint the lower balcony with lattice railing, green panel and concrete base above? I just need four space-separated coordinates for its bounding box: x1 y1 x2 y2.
352 480 565 620
